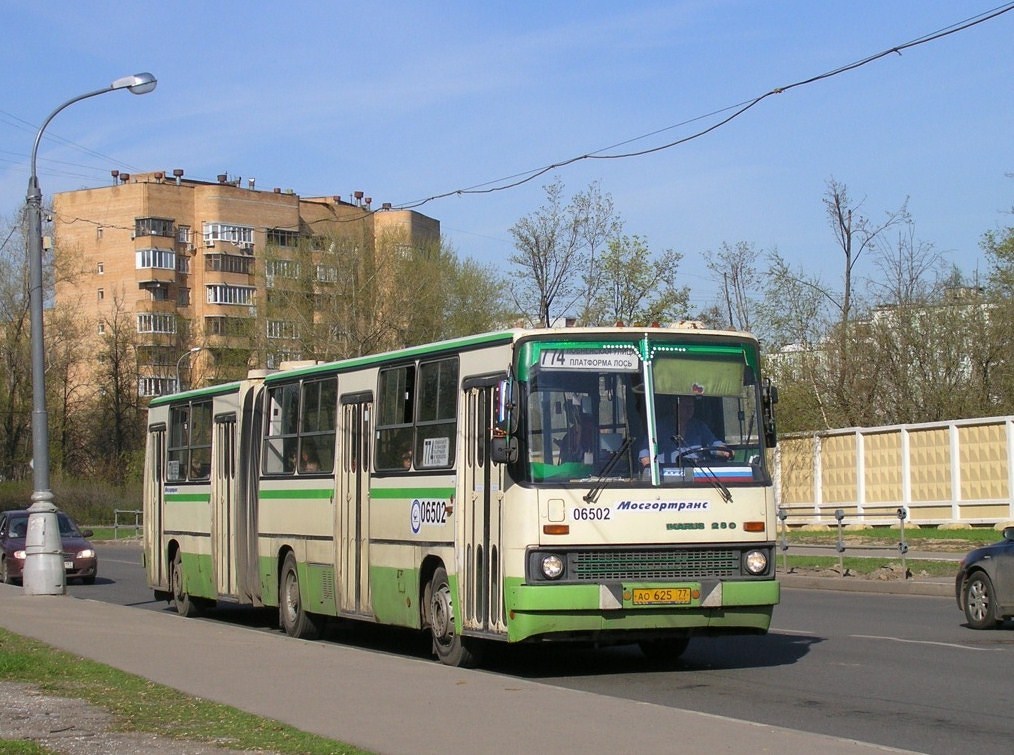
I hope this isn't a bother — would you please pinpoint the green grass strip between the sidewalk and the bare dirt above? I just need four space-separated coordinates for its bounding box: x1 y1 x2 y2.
0 629 366 755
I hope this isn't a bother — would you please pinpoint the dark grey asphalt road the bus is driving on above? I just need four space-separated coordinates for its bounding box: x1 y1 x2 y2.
79 544 1014 754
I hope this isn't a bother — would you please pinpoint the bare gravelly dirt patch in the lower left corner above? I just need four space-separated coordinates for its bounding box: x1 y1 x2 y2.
0 682 271 755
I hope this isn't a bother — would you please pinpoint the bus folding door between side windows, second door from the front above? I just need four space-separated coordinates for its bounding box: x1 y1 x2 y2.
336 393 373 615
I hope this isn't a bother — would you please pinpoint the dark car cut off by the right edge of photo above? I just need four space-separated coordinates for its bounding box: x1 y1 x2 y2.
954 527 1014 629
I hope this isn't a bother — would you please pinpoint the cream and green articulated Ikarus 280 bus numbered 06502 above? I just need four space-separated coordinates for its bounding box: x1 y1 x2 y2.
144 327 779 666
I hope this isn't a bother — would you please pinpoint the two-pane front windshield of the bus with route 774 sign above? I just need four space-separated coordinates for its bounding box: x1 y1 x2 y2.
520 344 769 485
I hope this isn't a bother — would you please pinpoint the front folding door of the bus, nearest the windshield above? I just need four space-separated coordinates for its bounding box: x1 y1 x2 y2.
455 379 507 632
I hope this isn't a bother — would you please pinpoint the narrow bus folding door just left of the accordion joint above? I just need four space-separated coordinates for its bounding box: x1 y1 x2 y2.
211 412 238 597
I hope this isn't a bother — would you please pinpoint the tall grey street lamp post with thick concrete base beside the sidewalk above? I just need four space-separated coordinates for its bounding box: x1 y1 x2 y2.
22 73 157 595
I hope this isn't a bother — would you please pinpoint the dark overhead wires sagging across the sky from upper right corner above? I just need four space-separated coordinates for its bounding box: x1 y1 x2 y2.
395 3 1014 210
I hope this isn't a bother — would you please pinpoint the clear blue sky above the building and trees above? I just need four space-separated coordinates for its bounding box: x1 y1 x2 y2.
0 0 1014 306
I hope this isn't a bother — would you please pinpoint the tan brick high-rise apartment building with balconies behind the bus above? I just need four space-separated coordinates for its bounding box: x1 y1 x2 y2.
53 169 440 396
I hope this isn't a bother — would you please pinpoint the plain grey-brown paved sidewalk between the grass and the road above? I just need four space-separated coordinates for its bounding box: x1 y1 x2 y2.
0 585 920 755
